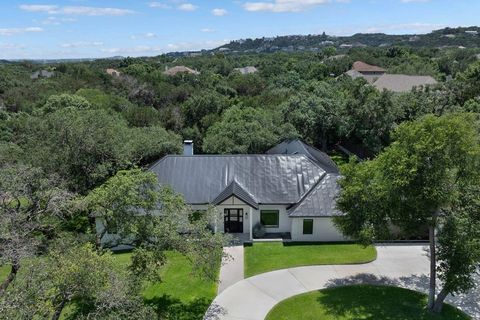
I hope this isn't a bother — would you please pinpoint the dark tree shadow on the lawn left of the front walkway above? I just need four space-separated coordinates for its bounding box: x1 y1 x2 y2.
145 295 211 320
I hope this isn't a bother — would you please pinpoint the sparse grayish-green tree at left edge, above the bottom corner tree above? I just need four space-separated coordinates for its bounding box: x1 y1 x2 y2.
0 164 72 296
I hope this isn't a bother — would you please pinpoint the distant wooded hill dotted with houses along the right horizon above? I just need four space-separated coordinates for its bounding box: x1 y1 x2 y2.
216 27 480 52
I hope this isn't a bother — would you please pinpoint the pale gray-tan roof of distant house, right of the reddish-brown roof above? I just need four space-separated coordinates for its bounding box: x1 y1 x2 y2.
373 74 437 92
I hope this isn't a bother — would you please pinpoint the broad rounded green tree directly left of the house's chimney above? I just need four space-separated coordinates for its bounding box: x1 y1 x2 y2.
16 108 181 193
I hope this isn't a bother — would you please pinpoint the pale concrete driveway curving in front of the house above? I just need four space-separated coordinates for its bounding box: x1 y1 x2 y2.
205 245 480 320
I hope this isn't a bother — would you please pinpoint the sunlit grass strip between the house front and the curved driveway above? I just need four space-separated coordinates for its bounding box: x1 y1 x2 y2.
245 242 377 277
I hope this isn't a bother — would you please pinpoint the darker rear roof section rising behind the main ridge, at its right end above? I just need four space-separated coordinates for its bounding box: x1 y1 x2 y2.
266 139 338 173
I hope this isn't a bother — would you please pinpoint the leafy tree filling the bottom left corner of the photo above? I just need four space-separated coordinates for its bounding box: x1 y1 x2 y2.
0 239 155 320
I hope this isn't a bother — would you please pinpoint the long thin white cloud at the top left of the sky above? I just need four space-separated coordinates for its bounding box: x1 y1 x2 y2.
19 4 135 16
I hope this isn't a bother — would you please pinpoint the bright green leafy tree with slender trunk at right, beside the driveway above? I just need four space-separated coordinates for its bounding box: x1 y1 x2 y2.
336 114 480 311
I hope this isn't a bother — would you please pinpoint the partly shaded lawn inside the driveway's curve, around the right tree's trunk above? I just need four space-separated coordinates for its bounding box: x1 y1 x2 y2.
266 285 470 320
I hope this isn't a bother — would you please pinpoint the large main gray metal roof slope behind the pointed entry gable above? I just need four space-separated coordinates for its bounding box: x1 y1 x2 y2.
150 154 326 204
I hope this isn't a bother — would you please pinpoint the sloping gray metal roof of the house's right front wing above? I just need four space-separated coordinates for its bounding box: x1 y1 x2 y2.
288 173 342 217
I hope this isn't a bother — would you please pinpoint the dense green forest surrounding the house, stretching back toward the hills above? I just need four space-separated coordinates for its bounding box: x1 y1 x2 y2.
0 41 480 319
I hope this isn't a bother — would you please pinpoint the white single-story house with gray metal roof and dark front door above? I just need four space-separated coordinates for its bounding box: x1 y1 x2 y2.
149 140 345 241
